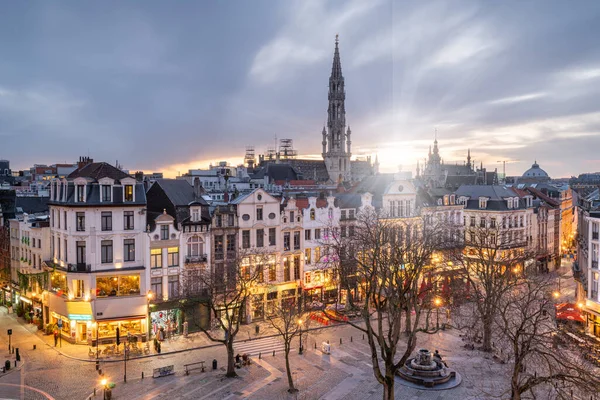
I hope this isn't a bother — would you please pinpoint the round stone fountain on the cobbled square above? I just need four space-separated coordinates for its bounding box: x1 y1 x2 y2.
397 349 462 390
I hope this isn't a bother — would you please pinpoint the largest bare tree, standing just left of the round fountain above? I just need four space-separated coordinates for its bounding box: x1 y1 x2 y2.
325 209 443 400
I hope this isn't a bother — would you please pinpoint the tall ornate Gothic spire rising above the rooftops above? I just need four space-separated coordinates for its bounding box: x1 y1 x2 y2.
322 35 352 183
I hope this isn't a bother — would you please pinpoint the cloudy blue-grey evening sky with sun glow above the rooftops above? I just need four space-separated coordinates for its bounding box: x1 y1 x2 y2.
0 0 600 177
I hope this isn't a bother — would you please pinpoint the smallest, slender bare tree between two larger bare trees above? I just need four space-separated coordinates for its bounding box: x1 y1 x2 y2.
267 302 308 393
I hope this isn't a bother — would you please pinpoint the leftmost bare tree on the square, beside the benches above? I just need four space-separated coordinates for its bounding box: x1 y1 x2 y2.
190 254 268 377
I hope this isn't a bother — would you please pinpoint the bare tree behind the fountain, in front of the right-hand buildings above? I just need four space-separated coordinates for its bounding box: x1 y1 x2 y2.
449 223 533 351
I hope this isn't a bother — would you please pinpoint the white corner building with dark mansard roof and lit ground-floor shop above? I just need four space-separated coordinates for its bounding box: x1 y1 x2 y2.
45 160 148 344
